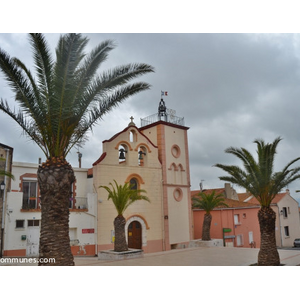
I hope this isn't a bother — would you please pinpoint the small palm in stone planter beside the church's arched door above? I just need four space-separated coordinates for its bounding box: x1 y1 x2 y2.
100 180 150 252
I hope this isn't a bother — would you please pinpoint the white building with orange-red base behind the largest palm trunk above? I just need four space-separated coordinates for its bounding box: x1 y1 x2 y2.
3 162 97 256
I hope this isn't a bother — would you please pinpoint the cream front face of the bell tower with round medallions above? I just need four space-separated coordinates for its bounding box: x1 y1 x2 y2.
158 124 192 245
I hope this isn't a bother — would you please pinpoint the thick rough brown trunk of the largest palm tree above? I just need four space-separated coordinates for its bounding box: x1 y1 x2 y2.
38 160 75 266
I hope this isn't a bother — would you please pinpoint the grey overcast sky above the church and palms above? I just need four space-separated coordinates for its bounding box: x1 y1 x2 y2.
0 33 300 199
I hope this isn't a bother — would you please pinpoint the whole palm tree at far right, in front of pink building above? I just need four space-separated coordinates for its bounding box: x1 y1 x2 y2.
215 137 300 266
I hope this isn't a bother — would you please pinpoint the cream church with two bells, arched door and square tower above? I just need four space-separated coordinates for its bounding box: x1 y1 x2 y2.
93 99 193 253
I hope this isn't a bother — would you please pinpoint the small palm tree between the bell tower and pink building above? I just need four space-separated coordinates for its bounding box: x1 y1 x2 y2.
192 191 228 241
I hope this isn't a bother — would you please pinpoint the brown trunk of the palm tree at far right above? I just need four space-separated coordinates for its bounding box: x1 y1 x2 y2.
257 207 280 266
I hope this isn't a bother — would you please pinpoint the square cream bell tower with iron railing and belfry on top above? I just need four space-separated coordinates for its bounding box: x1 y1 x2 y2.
140 98 192 250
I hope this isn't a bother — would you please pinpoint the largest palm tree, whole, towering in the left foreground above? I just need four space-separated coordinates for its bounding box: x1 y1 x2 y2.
0 33 154 265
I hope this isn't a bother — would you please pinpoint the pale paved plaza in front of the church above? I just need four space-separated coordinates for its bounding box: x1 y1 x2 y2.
75 247 300 266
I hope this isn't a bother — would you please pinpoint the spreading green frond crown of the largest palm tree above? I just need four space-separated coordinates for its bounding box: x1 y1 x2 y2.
0 33 154 158
